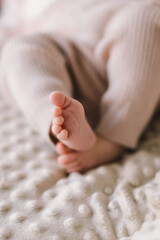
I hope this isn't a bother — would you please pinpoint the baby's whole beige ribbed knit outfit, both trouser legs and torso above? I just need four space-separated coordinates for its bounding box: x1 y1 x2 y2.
0 0 160 148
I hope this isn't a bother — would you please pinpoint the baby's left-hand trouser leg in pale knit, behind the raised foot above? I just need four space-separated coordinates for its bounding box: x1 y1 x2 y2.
0 35 72 146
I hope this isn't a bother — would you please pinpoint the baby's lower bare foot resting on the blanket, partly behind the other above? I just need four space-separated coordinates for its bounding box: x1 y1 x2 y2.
56 138 124 173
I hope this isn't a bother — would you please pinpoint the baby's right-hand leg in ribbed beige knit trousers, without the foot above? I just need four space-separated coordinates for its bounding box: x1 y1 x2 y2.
97 1 160 148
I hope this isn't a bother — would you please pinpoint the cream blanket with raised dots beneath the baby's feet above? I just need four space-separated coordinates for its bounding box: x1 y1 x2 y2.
0 92 160 240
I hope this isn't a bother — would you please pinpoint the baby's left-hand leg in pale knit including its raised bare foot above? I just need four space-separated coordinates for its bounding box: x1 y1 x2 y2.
1 35 95 150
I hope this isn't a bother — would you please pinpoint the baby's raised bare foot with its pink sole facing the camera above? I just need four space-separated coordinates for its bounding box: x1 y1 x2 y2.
49 91 96 151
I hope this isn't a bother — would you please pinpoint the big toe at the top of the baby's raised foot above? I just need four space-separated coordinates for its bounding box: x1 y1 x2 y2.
49 91 71 108
